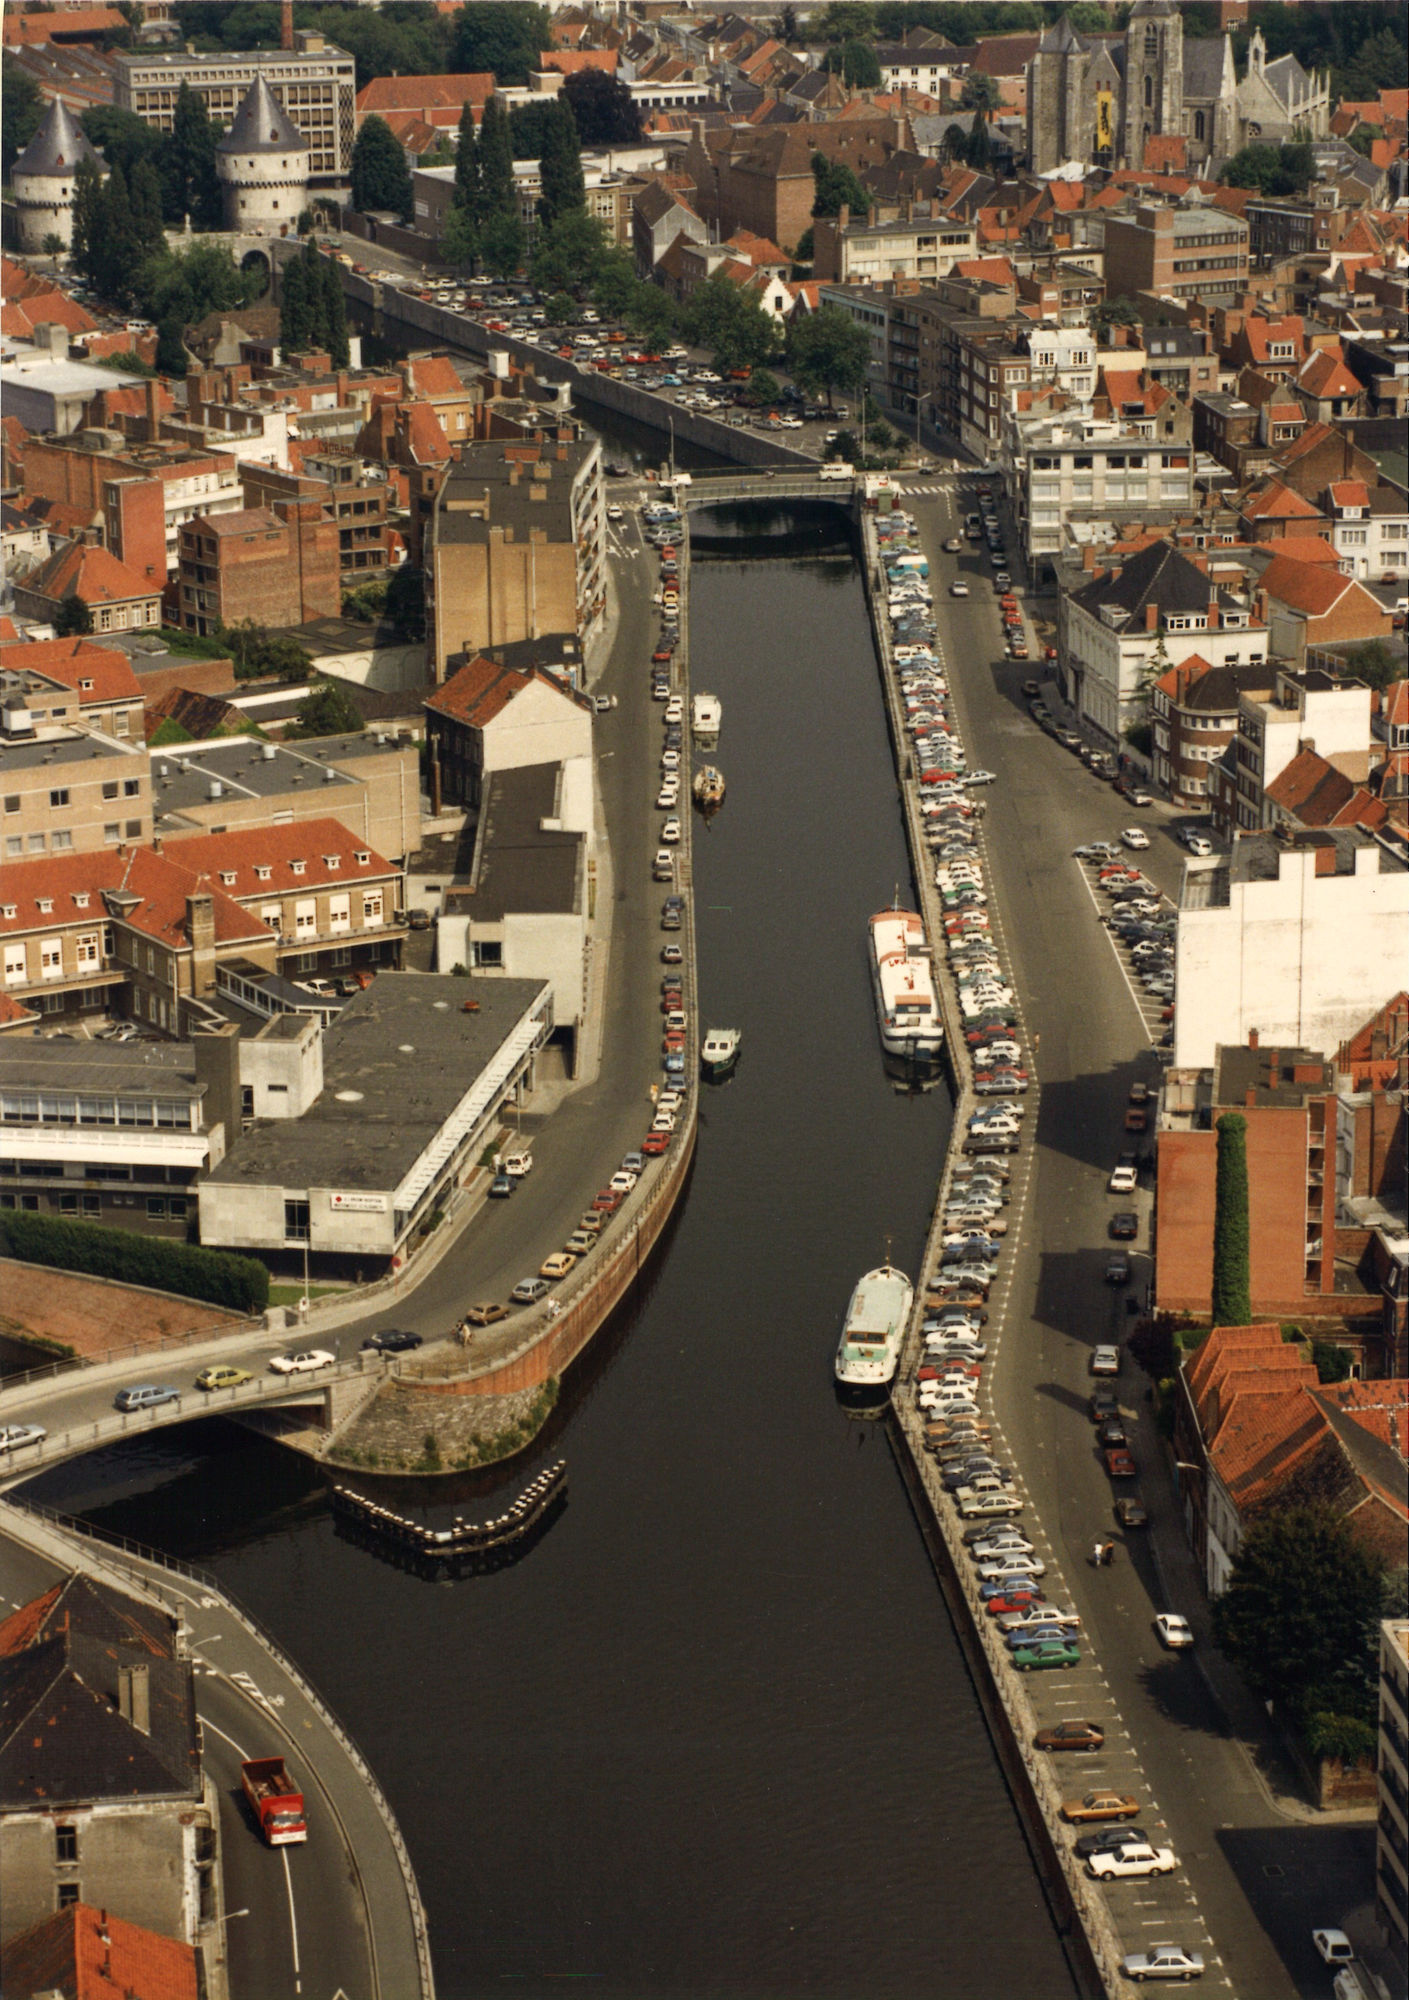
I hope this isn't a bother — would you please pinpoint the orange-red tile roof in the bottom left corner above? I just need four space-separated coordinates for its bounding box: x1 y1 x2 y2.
0 1896 204 2000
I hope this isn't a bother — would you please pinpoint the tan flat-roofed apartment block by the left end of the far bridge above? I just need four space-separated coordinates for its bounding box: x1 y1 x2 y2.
426 430 606 682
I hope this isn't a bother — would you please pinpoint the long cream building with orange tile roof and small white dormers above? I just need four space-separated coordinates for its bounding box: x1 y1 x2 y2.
0 818 406 1036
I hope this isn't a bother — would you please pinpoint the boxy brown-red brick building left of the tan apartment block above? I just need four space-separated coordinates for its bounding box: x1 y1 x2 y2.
180 498 342 634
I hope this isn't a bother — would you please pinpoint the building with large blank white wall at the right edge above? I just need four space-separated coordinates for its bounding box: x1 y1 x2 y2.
1173 828 1409 1070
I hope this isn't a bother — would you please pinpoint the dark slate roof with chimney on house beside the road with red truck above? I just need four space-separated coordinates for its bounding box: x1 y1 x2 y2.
0 1574 200 1810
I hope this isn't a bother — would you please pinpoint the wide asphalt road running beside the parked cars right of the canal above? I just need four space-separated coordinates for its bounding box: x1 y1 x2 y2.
905 476 1373 2000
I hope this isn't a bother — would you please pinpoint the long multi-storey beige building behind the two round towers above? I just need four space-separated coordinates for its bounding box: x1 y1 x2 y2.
112 30 356 188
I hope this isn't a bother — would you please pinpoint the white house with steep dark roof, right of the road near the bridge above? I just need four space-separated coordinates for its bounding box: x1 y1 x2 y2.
1057 542 1267 740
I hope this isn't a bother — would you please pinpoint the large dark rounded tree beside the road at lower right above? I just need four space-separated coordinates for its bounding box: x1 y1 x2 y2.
1213 1502 1383 1716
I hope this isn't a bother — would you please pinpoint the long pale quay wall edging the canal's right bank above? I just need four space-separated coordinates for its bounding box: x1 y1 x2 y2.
861 510 1125 2000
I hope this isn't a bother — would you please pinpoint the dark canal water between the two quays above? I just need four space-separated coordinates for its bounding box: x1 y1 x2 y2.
27 510 1073 2000
